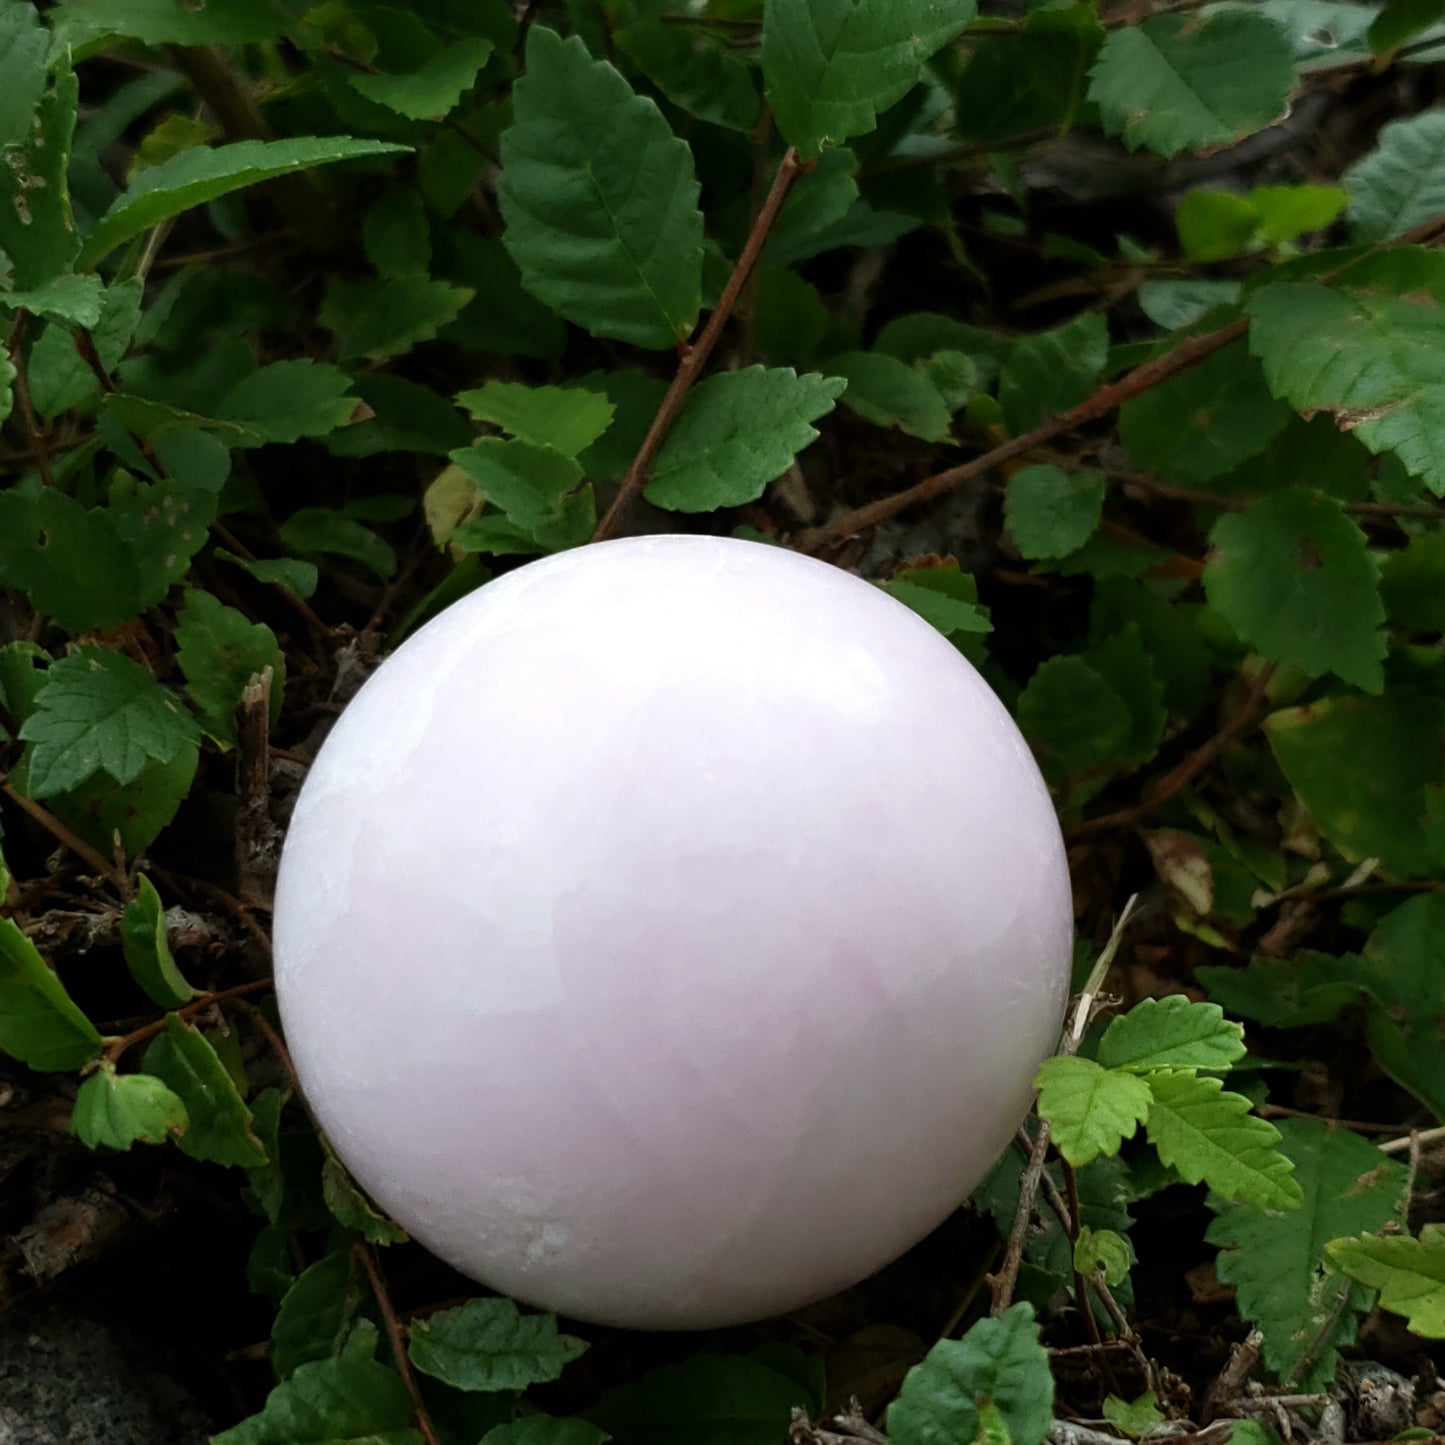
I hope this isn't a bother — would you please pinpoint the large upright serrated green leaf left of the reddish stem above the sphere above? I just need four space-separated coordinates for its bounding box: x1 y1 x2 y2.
497 25 702 350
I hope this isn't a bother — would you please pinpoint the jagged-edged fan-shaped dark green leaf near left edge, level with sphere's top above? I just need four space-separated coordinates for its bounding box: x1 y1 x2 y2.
20 647 197 798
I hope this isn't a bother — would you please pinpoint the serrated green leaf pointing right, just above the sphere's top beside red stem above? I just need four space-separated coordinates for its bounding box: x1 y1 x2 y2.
644 366 847 512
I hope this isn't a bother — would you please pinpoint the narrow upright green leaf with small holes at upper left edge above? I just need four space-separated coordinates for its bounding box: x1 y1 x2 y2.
0 62 81 290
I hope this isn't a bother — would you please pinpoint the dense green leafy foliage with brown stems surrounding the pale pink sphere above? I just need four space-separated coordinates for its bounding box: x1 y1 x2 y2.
0 0 1445 1445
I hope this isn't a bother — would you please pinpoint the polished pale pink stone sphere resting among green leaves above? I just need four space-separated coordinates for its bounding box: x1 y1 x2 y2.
275 536 1072 1329
